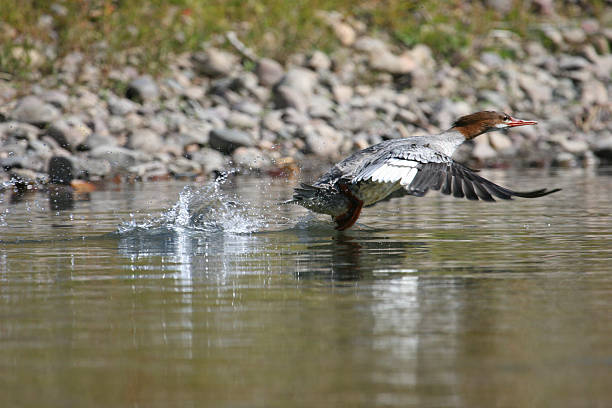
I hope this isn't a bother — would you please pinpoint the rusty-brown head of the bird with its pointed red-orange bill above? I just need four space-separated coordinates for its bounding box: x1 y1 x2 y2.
452 111 538 140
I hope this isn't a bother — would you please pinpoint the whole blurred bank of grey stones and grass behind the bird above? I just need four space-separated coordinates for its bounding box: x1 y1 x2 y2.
0 0 612 182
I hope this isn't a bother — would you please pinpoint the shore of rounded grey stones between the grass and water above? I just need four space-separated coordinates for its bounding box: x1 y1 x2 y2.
0 13 612 187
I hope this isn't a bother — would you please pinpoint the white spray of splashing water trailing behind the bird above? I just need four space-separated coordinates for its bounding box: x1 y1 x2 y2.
118 174 268 234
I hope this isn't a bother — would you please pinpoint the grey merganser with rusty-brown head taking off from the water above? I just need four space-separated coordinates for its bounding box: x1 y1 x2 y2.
286 111 560 231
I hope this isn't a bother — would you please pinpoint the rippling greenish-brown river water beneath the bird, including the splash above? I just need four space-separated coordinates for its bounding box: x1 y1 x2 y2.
0 171 612 407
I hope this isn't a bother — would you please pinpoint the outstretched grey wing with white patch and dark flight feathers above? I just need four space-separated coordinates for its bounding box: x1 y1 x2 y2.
351 152 560 201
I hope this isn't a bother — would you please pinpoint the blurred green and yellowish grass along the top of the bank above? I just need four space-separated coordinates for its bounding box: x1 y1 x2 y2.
0 0 605 81
